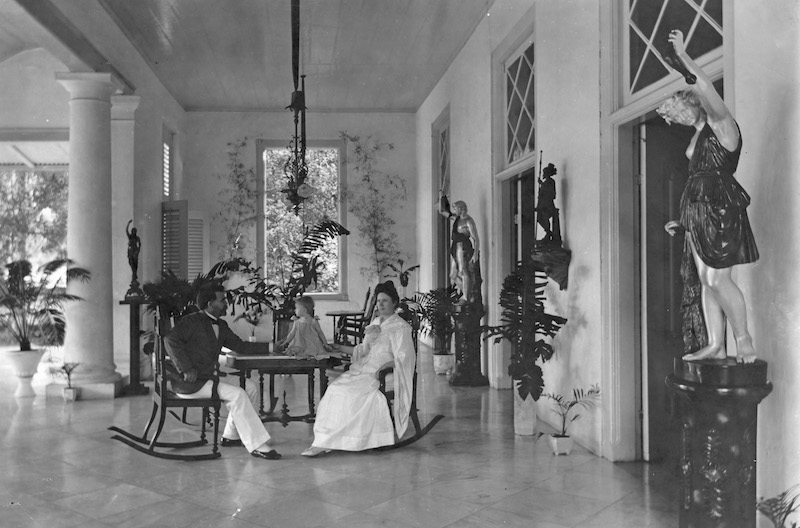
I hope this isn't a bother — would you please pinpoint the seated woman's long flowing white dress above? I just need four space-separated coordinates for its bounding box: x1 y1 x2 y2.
313 314 416 451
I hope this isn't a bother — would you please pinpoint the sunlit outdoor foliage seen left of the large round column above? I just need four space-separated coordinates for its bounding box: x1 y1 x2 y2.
0 170 67 262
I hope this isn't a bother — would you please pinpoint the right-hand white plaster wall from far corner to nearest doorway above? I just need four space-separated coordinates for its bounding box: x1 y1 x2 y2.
416 0 601 451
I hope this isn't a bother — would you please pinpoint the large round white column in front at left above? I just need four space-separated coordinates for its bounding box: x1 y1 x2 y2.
56 73 122 398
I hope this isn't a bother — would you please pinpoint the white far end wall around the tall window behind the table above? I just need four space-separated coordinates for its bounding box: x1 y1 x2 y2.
184 110 417 338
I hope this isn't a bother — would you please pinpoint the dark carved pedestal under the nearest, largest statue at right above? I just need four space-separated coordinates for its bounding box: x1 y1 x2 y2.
666 358 772 528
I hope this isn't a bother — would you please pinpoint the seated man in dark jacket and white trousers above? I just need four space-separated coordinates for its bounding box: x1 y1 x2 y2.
164 284 281 460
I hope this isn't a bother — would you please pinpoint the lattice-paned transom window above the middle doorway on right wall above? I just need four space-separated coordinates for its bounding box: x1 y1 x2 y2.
505 42 536 166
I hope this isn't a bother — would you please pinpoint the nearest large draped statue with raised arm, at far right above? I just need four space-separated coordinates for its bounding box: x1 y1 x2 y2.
657 30 759 363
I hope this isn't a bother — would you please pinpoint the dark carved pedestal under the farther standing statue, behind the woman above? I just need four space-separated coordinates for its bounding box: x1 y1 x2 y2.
449 302 489 387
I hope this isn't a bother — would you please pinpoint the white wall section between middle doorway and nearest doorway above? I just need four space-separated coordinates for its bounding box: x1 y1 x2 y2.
531 0 608 452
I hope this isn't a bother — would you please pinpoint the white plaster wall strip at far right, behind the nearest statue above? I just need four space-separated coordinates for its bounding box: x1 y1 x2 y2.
726 0 800 512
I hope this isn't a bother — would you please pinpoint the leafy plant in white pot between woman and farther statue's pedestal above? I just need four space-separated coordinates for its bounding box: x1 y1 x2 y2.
413 286 460 375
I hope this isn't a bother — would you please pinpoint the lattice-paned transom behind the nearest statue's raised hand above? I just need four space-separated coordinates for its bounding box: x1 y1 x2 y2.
623 0 722 99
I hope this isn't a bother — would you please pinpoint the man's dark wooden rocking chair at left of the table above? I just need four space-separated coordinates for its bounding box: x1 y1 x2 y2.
108 312 222 460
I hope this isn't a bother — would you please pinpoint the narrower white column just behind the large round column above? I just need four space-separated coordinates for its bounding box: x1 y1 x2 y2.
111 95 142 371
